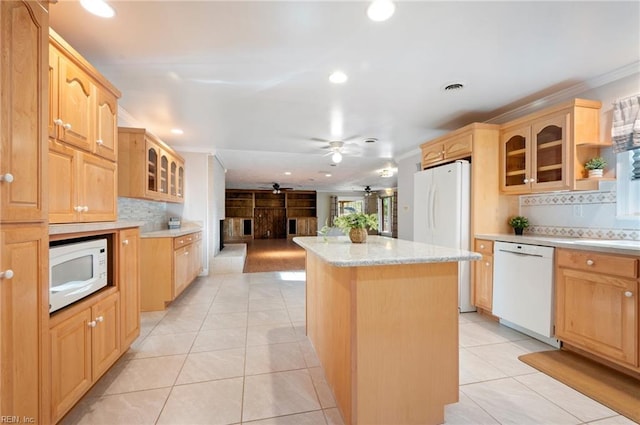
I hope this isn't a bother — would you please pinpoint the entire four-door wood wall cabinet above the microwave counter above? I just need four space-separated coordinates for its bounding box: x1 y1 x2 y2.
48 30 120 223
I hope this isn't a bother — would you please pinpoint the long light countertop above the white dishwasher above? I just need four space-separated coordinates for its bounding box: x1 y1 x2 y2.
475 234 640 256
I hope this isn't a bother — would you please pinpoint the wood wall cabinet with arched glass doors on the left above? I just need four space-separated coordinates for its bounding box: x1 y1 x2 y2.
118 127 185 203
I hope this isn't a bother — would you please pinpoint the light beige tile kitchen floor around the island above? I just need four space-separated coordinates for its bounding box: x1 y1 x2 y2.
62 272 633 425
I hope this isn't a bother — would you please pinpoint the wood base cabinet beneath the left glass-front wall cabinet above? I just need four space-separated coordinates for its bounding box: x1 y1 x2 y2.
140 232 202 311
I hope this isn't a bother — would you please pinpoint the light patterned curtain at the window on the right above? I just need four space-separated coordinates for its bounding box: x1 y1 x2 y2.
611 94 640 152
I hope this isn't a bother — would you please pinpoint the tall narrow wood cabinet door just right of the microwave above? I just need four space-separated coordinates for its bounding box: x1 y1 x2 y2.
118 228 140 347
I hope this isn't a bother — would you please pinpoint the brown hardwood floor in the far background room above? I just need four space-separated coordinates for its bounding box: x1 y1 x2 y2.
243 239 305 273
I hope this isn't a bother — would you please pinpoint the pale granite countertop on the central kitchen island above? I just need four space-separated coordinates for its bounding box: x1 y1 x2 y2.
293 236 482 267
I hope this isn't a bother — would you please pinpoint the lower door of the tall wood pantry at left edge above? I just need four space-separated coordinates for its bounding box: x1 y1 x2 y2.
0 224 49 423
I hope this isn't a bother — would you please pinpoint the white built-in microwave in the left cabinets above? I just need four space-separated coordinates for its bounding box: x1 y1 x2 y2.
49 238 107 313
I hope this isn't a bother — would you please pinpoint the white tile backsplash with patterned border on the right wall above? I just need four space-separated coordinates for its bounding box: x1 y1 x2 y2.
519 187 640 240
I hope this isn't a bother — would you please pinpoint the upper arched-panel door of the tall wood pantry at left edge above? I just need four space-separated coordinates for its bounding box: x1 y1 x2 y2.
0 1 48 223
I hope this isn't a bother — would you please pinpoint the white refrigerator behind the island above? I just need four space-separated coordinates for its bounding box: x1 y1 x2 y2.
413 161 475 312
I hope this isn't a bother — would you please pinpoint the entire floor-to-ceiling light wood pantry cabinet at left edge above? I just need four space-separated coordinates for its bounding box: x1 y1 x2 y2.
0 0 49 424
